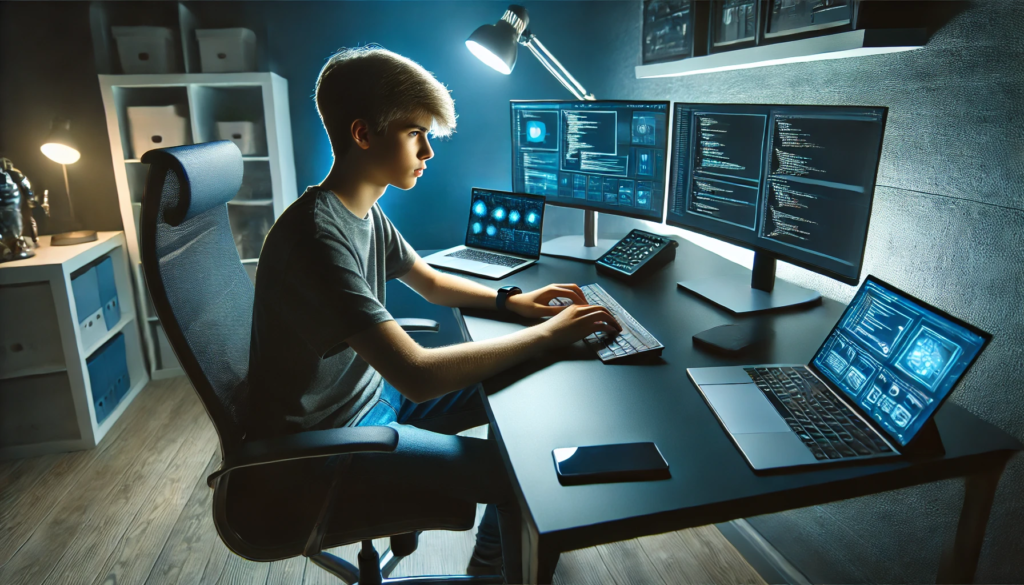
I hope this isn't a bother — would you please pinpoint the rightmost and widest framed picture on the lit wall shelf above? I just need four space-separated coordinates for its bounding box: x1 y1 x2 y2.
765 0 856 41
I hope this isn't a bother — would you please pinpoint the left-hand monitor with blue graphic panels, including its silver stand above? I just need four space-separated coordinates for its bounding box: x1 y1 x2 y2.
511 100 669 261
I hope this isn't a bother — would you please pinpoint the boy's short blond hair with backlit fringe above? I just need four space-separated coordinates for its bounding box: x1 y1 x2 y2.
315 45 456 156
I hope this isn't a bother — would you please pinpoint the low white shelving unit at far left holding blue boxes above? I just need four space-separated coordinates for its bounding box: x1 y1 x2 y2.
0 232 150 459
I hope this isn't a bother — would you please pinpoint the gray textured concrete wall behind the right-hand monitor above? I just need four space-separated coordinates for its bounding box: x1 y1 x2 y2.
581 0 1024 583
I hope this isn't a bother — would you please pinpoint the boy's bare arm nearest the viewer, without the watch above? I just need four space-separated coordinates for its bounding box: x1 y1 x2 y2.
346 295 621 403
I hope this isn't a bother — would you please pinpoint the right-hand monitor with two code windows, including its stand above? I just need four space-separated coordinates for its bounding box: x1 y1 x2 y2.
666 103 888 312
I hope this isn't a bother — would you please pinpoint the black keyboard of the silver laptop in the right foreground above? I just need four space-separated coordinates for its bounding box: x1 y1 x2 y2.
743 367 892 460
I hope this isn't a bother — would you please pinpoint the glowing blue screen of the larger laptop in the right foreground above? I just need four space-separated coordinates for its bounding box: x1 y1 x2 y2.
812 277 989 446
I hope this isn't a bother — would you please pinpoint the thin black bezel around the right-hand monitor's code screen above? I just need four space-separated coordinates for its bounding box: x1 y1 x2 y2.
664 101 889 285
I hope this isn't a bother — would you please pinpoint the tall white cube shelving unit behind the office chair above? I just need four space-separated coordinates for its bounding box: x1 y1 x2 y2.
99 73 297 379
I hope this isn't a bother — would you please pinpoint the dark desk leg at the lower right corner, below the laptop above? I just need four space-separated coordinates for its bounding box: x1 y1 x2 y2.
936 462 1006 583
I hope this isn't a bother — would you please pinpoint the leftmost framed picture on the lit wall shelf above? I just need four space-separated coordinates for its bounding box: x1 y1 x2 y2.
641 0 696 65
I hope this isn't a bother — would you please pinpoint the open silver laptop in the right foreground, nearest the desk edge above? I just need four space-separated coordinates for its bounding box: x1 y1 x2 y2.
686 277 991 470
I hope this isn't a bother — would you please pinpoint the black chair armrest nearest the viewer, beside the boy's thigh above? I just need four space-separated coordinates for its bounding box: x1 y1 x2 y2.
206 426 398 488
